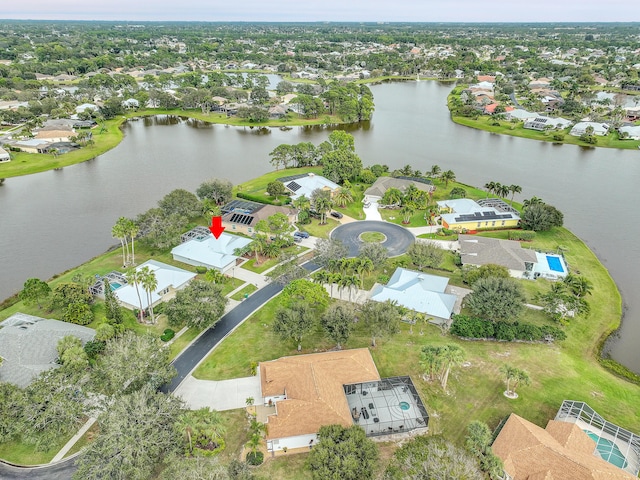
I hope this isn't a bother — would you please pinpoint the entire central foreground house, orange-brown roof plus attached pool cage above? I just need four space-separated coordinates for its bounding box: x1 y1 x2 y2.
259 348 429 453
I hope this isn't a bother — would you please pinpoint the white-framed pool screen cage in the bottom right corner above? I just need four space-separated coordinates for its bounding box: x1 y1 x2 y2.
555 400 640 476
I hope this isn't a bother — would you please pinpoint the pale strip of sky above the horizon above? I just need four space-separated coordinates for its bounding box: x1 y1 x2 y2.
0 0 640 22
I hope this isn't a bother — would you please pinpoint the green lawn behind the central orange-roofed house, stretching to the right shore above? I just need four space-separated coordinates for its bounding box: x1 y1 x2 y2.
195 224 640 450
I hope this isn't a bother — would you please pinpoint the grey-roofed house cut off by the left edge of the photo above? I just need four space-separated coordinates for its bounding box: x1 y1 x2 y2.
0 313 96 388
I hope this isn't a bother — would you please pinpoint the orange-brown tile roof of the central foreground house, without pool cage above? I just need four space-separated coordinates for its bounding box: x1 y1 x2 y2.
260 348 380 439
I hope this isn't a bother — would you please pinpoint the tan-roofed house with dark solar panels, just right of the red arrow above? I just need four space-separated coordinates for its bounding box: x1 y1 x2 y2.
221 200 296 237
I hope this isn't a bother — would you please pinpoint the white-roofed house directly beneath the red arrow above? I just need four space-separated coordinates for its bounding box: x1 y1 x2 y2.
171 233 252 273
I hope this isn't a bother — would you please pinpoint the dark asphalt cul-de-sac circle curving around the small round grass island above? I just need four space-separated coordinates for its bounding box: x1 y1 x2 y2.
331 220 415 257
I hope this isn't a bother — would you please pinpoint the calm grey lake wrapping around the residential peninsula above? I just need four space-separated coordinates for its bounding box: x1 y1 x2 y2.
0 81 640 372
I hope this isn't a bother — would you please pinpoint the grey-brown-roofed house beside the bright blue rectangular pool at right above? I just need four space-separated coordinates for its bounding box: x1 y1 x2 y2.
458 234 538 278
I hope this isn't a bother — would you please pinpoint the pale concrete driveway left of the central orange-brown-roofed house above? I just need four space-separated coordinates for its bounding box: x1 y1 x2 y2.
174 375 262 412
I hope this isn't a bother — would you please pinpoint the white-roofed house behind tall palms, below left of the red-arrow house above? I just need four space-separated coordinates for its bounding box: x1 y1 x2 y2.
113 260 196 310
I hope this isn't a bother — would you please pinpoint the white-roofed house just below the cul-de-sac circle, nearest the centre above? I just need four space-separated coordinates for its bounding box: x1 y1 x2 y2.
371 268 457 319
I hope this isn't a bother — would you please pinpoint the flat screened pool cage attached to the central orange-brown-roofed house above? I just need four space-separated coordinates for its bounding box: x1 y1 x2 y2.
343 376 429 436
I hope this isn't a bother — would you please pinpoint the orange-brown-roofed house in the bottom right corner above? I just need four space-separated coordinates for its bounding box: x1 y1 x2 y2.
492 413 637 480
